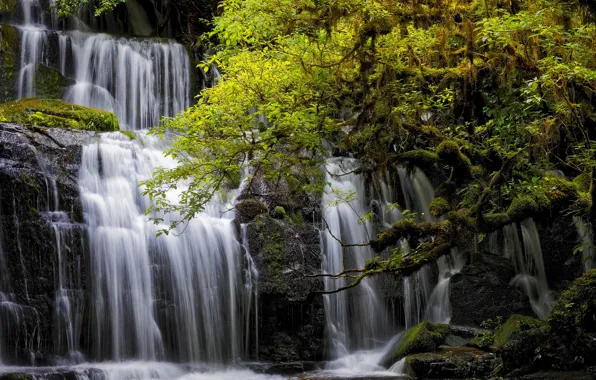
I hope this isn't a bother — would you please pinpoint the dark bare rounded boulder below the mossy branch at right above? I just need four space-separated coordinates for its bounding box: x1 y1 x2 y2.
449 252 534 327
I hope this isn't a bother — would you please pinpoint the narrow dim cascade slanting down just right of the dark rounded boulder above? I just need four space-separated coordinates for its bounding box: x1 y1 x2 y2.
503 219 554 319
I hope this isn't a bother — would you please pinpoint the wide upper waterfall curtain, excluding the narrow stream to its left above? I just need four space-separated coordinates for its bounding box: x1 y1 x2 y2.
60 31 190 130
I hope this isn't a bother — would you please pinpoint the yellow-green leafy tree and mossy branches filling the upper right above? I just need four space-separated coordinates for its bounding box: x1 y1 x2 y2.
144 0 596 286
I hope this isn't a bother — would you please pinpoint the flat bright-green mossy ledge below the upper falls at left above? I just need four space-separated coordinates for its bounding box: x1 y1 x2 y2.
0 98 119 132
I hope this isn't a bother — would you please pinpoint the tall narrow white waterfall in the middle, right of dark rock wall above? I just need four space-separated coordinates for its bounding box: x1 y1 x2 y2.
321 158 388 358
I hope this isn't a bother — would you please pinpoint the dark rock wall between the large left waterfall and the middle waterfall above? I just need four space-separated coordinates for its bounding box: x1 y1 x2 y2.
247 214 325 362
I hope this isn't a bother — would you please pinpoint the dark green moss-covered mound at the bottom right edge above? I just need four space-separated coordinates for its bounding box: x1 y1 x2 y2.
548 269 596 334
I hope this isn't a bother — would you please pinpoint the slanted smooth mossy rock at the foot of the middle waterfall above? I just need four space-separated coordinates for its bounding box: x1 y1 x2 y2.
381 322 450 368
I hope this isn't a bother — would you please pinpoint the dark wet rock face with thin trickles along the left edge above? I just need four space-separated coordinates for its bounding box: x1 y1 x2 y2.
0 123 94 364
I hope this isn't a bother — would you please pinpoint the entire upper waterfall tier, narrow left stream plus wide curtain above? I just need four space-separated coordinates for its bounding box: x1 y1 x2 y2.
12 0 191 130
